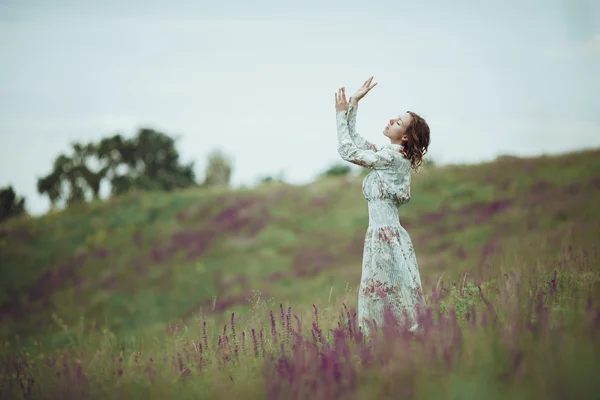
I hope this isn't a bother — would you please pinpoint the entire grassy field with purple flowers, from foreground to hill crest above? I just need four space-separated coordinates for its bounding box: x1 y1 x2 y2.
0 149 600 400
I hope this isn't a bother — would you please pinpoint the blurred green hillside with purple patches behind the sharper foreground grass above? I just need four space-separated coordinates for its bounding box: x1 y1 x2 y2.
0 149 600 337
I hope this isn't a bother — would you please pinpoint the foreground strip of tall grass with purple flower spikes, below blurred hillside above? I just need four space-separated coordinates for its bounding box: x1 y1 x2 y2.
0 247 600 400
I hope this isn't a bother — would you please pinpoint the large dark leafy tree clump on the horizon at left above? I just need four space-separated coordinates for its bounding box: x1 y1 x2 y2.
37 129 195 206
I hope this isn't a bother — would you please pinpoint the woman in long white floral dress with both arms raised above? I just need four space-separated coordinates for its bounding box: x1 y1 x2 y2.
336 77 429 335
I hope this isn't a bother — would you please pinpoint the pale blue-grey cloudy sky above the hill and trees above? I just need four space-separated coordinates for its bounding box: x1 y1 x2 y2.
0 0 600 215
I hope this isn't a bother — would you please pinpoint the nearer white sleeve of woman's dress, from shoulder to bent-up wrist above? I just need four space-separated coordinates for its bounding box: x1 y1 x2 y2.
336 111 395 169
